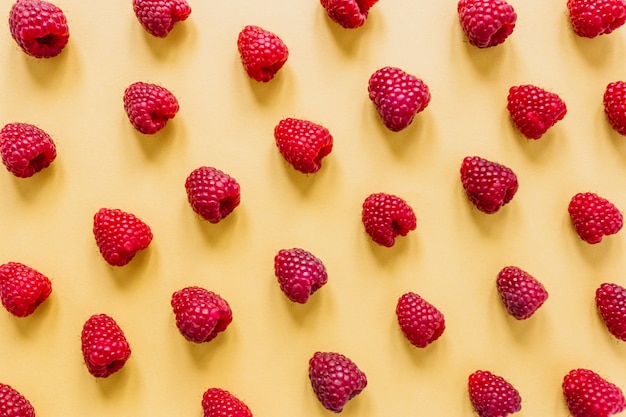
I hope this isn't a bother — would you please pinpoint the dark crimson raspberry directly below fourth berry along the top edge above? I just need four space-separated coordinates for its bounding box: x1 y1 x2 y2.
461 156 519 214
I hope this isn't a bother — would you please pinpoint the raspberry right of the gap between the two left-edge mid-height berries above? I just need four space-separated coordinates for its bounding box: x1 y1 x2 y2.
93 208 152 266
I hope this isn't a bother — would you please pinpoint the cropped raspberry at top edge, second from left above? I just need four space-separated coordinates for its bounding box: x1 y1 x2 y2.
133 0 191 38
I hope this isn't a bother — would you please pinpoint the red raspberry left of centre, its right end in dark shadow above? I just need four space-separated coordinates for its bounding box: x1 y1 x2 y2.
185 166 241 223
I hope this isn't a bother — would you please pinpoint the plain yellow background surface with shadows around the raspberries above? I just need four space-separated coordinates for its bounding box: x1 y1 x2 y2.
0 0 626 417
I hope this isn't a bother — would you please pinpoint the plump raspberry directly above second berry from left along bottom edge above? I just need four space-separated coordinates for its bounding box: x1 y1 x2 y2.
171 286 233 343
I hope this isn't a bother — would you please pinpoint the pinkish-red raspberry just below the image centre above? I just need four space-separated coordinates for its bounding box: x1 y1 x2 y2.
274 248 328 304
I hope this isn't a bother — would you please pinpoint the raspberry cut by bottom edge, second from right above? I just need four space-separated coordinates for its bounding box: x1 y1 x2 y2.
468 370 522 417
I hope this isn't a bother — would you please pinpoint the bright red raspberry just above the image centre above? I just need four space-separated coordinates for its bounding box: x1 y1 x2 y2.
274 118 333 174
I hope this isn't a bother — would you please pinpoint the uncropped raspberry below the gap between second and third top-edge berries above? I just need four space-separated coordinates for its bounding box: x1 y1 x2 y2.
237 25 289 82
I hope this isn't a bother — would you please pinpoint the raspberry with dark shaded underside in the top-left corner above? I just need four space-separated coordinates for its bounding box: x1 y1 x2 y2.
9 0 70 58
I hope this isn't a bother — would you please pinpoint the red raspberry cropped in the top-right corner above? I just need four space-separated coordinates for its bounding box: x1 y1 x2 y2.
567 0 626 38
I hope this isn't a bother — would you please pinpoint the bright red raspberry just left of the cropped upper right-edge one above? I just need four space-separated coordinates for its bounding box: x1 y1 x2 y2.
507 85 567 139
